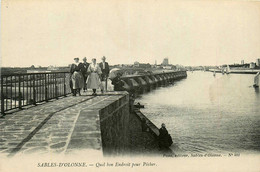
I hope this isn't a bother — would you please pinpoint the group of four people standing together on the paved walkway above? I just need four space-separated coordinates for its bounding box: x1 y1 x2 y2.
70 56 109 96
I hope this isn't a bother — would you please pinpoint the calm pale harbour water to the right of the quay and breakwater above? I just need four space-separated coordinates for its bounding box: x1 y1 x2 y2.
136 72 260 154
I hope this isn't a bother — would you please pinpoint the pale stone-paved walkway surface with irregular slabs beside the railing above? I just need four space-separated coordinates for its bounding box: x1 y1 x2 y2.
0 92 127 156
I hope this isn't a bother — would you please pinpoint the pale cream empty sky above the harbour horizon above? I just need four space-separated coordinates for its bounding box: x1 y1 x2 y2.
1 0 260 67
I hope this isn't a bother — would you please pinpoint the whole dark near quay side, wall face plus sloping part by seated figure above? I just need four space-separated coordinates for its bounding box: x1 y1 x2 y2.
97 92 171 156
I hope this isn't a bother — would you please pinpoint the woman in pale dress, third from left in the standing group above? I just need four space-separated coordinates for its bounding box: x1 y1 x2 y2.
86 58 102 96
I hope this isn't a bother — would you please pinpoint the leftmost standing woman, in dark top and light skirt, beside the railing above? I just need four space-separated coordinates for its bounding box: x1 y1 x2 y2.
70 58 84 96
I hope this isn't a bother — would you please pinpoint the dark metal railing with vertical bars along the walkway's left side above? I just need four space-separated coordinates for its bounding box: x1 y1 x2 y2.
1 72 71 115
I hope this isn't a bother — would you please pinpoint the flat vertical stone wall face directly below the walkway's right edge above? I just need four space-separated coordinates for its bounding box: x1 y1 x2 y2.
99 93 130 155
